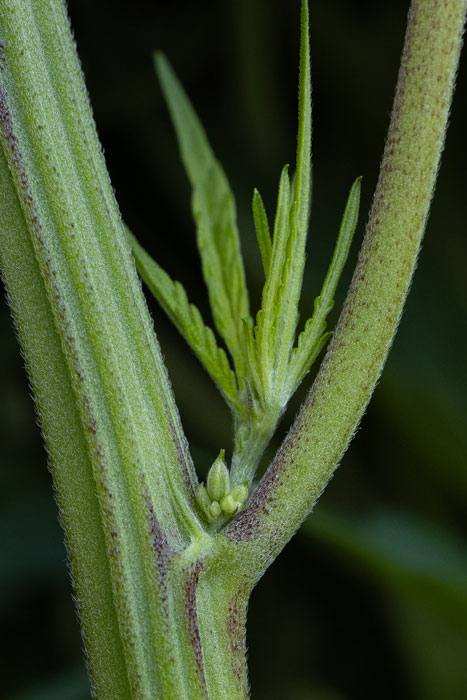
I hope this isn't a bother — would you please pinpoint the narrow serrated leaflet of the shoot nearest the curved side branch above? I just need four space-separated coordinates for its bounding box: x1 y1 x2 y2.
288 177 361 396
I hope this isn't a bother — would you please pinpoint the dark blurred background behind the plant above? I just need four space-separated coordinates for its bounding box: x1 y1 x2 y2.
0 0 467 700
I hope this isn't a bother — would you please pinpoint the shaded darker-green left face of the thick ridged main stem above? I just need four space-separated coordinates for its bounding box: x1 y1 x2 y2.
0 141 129 698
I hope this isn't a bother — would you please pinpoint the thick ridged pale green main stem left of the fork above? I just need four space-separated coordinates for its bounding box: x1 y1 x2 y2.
0 0 202 698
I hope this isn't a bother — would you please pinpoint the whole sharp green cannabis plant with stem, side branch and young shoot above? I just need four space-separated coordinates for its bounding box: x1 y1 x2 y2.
0 0 466 700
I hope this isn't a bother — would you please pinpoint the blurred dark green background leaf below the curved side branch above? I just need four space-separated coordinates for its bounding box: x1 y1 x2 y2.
304 508 467 625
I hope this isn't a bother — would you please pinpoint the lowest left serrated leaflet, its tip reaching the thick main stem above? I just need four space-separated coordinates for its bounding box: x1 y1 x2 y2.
126 229 243 413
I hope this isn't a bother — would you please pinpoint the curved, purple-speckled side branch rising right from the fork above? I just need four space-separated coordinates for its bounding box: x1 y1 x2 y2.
225 0 467 582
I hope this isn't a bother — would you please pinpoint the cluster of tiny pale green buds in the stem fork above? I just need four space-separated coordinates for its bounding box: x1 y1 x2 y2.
196 450 248 522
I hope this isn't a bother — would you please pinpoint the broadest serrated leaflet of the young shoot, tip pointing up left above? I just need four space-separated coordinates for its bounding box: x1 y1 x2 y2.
155 54 249 374
